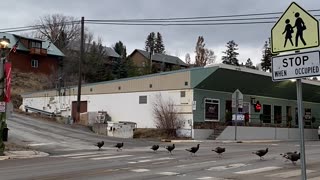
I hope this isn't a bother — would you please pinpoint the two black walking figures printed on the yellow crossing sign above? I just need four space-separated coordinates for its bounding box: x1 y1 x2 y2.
282 12 307 47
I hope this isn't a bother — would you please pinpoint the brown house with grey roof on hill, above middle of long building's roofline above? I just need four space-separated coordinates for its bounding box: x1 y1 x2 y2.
129 49 189 73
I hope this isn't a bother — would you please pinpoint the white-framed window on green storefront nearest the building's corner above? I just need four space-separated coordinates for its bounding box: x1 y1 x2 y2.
204 98 220 121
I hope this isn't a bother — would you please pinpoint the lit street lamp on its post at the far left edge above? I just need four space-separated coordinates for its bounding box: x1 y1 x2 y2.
0 36 10 156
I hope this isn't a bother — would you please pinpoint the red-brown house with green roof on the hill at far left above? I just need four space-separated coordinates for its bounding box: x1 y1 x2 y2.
0 33 64 75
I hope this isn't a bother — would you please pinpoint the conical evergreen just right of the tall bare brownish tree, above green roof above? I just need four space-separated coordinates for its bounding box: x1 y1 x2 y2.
222 40 239 66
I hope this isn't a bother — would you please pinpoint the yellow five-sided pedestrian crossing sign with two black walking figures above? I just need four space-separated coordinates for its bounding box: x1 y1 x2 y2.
271 2 320 53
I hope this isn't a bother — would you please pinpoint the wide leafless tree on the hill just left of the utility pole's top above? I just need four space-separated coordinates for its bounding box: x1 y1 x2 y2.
36 14 81 50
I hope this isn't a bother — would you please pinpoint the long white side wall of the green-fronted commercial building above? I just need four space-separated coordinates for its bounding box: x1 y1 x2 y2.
21 90 193 129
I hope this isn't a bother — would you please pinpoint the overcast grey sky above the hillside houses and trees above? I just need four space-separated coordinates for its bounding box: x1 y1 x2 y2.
0 0 320 64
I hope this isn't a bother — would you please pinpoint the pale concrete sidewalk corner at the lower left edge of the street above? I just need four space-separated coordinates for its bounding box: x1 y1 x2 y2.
0 150 49 161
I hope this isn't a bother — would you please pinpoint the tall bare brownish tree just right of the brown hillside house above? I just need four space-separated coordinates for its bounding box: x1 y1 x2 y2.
195 36 216 66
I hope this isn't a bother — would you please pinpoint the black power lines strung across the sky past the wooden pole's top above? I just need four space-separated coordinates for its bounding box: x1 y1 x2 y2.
0 9 320 32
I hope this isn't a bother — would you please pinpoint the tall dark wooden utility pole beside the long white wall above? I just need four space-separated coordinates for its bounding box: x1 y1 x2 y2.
76 17 84 121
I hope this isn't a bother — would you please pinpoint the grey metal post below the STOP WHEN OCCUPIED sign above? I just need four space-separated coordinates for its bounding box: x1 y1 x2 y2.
297 79 307 180
